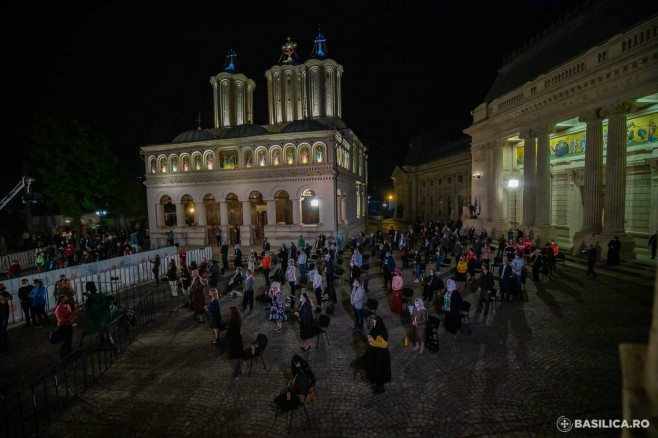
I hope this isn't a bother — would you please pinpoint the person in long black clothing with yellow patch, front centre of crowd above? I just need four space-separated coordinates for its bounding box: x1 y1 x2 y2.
365 316 391 394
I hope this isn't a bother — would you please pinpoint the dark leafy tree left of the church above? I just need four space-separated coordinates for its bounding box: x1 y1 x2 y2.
29 118 116 222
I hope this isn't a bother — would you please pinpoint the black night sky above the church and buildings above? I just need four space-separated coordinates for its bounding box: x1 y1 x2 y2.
0 0 600 192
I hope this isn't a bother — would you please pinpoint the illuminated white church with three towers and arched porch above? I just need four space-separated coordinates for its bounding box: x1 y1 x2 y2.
141 34 368 245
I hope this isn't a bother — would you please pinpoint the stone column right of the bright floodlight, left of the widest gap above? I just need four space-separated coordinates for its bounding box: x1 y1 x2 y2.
526 125 555 229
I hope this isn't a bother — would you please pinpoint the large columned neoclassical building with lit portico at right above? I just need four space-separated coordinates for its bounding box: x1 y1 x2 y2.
464 9 658 258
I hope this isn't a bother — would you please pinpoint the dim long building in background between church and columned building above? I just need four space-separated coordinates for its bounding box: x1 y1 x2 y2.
391 133 471 223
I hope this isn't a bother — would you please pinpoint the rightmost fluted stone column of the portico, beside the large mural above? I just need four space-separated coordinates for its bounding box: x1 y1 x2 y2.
603 102 634 234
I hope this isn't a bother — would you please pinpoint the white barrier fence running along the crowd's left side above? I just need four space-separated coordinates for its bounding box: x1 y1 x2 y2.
4 247 212 325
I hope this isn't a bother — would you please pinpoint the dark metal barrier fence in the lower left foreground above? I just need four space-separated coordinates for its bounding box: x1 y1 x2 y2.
0 291 157 437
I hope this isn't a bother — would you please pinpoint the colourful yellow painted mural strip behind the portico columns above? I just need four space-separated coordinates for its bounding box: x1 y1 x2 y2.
516 113 658 164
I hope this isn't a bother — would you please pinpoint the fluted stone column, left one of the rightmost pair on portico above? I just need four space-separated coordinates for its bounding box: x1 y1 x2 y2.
579 109 604 234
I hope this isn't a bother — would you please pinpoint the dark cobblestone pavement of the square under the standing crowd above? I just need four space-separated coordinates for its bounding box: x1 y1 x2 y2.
39 253 652 437
